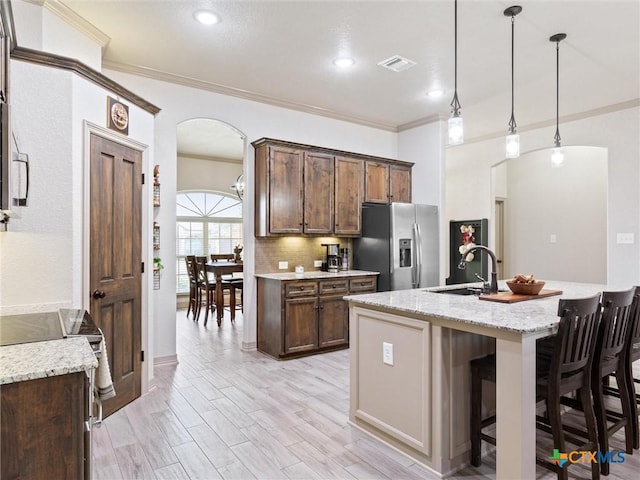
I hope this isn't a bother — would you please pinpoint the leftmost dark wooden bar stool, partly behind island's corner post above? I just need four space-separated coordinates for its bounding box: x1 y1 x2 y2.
470 294 600 480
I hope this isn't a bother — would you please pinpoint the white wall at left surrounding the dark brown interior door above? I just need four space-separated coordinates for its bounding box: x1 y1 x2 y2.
0 61 154 386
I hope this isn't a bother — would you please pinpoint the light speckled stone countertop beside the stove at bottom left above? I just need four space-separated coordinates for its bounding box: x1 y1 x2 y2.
0 337 98 385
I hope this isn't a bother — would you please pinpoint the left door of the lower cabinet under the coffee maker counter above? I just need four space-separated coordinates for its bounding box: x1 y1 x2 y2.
283 297 318 354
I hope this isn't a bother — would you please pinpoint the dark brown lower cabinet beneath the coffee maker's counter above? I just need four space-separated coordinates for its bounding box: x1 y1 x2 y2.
258 275 377 358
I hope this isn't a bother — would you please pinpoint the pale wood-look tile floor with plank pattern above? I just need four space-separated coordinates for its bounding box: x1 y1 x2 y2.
93 310 640 480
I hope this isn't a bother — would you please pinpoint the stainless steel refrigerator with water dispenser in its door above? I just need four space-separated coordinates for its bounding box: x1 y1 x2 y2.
353 203 439 291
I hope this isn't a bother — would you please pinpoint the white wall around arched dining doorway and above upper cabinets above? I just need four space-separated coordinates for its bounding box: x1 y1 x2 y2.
105 67 397 358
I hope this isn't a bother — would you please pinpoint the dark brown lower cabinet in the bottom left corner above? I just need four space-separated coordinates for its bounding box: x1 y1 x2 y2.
0 372 90 480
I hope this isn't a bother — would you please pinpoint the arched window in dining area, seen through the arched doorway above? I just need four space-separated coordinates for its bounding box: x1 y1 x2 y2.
176 192 242 293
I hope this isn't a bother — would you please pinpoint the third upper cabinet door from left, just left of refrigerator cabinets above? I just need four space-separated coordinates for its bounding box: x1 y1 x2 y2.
333 157 364 235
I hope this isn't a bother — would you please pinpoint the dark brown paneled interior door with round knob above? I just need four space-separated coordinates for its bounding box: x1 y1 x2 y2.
89 134 142 416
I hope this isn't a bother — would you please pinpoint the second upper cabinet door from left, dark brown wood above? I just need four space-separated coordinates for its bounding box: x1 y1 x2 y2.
304 152 333 234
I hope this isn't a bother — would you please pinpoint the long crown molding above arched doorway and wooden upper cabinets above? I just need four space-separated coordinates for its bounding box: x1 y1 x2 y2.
102 60 398 132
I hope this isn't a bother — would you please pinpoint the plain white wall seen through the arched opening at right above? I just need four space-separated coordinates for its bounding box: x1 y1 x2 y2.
504 147 608 284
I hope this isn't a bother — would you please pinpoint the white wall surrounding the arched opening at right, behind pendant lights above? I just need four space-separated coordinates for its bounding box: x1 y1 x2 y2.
442 106 640 288
